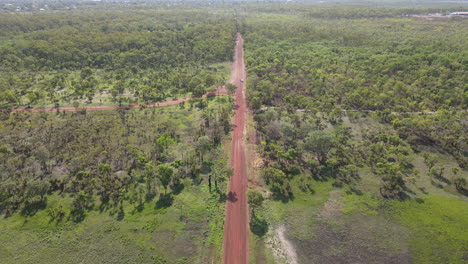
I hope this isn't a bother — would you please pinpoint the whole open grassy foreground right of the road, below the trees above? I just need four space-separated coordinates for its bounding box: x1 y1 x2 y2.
258 175 468 263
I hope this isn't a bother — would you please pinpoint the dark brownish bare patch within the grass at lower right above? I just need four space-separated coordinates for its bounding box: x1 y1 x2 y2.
294 216 411 264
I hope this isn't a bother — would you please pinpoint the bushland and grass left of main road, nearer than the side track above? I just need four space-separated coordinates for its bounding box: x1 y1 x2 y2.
0 97 232 263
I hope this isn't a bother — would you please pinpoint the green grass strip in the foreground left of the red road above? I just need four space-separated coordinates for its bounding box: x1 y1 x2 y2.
0 180 224 263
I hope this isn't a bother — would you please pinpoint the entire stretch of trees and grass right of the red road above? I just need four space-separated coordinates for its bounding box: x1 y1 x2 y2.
245 5 468 263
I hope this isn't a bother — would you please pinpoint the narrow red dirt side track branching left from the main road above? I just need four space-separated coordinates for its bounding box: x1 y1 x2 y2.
11 90 228 113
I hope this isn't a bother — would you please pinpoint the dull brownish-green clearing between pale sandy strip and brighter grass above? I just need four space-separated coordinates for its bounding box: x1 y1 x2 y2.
264 178 406 263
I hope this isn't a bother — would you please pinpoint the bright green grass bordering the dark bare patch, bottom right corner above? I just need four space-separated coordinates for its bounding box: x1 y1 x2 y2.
342 194 468 263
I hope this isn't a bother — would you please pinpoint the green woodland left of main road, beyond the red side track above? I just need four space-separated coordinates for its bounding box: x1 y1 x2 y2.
0 5 236 110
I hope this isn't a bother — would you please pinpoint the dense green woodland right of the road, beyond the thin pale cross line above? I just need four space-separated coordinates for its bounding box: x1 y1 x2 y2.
244 14 467 112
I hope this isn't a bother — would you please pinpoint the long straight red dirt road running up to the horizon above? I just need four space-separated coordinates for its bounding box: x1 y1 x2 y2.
223 33 248 264
